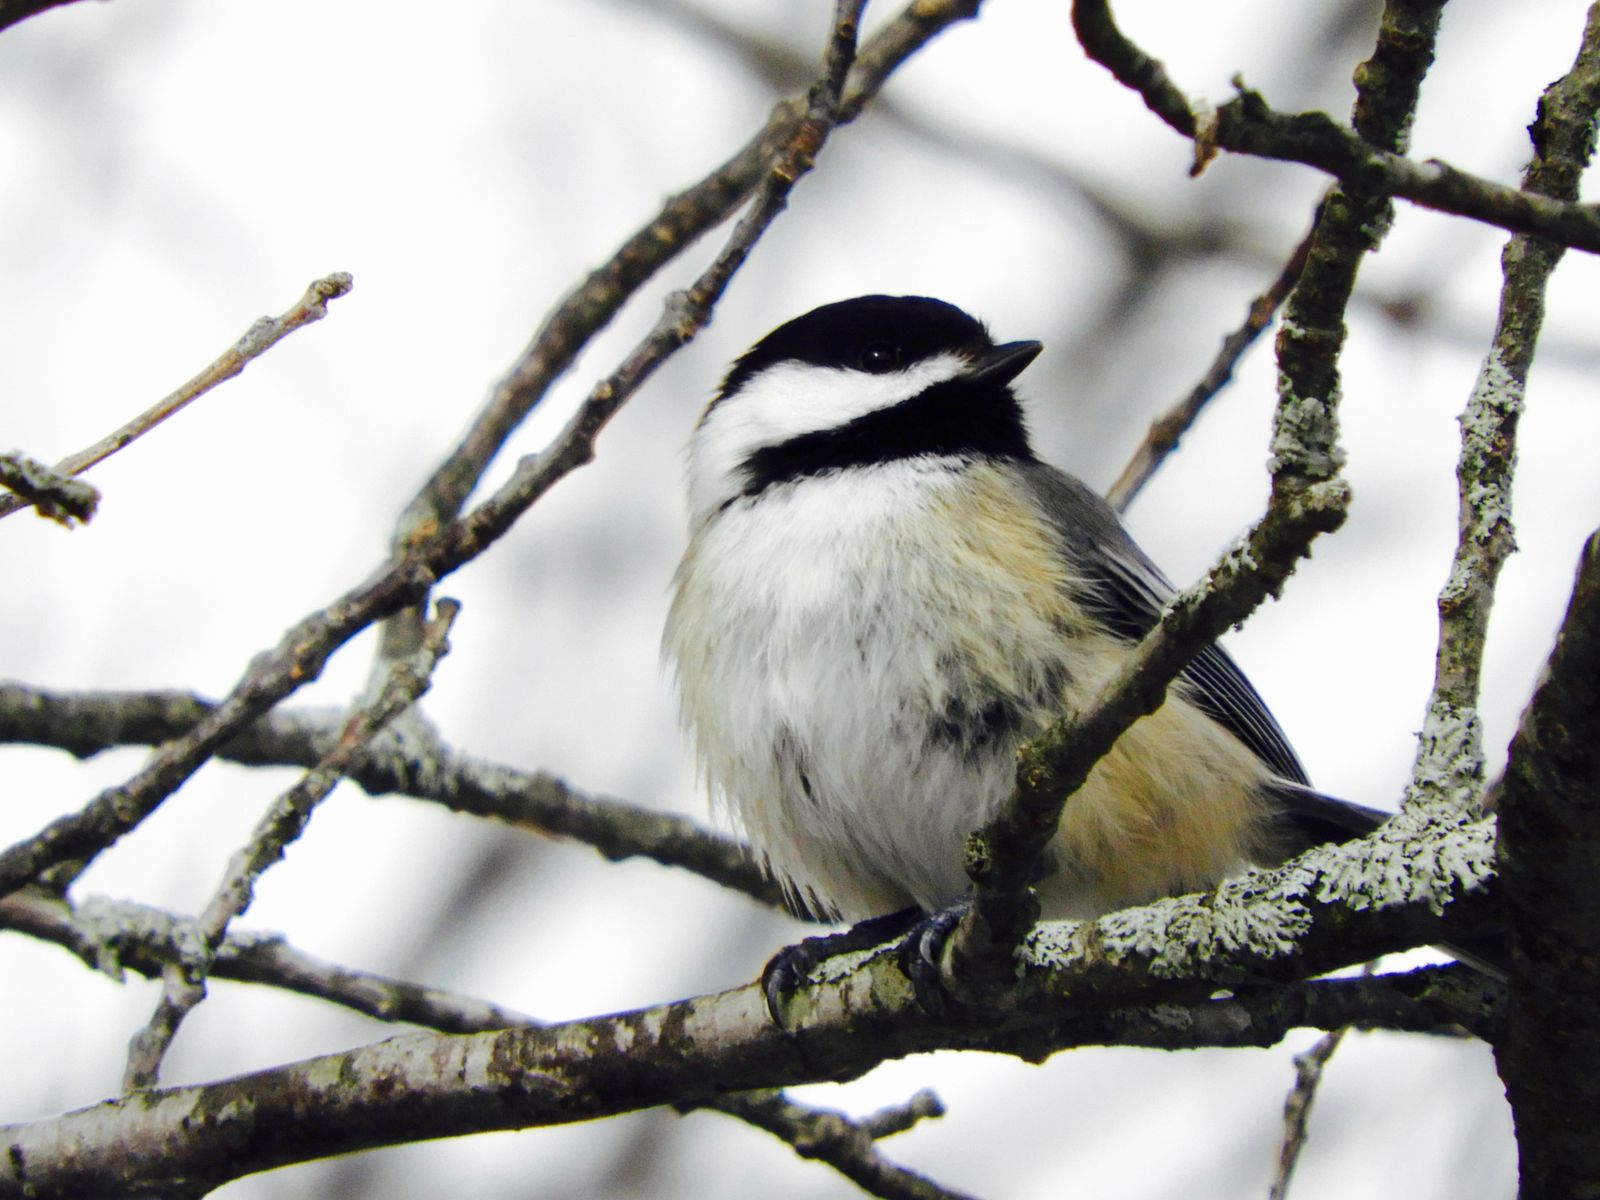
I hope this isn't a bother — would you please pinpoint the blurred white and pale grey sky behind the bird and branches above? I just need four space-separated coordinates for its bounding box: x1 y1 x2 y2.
0 0 1600 1200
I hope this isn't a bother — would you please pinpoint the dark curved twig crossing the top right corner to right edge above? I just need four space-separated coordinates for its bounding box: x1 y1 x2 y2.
1072 0 1600 253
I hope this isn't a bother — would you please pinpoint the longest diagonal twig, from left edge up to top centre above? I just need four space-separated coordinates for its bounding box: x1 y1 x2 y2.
0 0 976 896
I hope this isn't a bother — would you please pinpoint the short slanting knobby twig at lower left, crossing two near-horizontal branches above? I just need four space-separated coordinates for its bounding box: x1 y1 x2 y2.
122 600 459 1091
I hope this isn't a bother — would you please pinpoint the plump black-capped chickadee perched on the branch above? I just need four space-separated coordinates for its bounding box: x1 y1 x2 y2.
662 296 1386 985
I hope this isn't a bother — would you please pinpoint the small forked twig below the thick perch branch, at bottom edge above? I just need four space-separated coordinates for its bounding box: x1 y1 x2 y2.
704 1088 971 1200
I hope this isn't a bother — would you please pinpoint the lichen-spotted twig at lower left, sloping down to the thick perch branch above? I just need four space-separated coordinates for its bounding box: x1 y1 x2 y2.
0 888 533 1034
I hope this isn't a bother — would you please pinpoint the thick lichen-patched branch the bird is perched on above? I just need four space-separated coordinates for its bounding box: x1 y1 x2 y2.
0 827 1498 1200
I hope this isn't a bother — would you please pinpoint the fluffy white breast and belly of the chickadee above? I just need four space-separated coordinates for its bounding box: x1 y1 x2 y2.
666 459 1074 915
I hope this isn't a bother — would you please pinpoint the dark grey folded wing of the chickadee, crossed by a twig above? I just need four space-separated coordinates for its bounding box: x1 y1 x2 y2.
1022 462 1312 790
